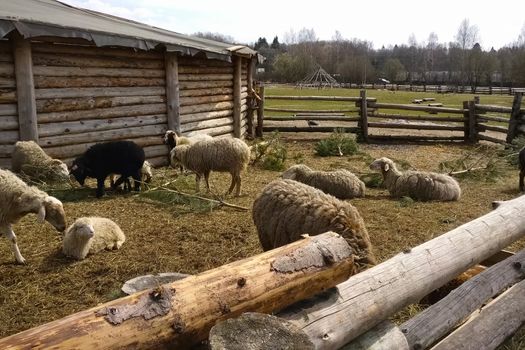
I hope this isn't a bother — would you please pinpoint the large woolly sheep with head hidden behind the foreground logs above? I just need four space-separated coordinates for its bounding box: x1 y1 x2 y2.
252 179 377 270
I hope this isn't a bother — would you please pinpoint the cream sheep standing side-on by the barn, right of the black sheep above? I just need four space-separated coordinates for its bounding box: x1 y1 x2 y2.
171 138 250 197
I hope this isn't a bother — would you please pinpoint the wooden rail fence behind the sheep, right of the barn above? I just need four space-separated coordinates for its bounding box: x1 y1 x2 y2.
258 90 525 144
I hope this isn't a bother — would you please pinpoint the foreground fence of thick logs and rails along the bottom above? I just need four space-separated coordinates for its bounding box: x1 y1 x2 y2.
0 196 525 350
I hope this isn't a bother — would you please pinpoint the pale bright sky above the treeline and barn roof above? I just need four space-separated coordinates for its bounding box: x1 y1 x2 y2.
62 0 525 50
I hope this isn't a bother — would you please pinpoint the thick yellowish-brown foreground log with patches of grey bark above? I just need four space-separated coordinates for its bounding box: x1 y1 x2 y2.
0 232 353 350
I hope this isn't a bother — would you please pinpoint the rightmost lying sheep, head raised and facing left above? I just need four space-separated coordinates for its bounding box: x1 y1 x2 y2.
370 157 461 201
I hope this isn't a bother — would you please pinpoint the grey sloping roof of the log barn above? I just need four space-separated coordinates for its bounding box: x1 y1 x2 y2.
0 0 257 61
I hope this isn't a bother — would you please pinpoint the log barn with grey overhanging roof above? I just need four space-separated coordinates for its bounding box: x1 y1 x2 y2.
0 0 259 168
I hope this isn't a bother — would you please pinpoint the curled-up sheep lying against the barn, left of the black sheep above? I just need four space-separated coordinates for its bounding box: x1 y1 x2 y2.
11 141 69 181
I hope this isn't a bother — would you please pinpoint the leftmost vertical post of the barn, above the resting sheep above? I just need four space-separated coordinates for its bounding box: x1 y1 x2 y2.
11 33 38 142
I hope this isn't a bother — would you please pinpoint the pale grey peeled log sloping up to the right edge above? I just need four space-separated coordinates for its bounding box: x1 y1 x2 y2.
278 196 525 349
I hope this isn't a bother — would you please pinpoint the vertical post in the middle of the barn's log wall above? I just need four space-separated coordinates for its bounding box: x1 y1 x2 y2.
165 52 180 133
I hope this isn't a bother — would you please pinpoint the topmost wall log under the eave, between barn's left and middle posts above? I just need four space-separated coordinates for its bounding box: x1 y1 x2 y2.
31 42 164 60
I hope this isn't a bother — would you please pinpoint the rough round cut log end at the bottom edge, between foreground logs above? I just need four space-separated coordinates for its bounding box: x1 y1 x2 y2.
209 312 314 350
